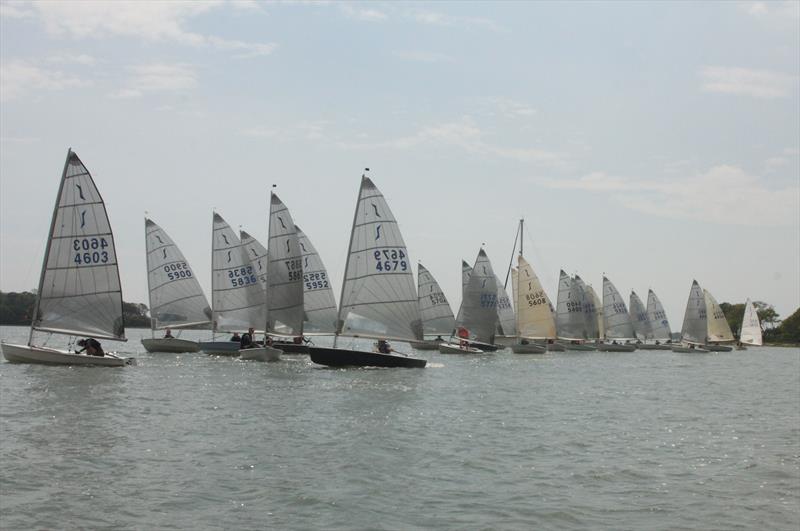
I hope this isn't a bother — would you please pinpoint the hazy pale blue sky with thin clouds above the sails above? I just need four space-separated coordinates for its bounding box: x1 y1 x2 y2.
0 1 800 330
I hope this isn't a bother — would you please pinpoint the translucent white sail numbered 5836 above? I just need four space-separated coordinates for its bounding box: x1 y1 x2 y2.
211 212 264 332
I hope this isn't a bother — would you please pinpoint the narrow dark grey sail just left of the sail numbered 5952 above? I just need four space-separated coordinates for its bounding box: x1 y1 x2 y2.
267 193 304 335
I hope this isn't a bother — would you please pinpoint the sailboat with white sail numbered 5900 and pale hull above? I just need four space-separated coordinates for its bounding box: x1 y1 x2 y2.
142 218 211 352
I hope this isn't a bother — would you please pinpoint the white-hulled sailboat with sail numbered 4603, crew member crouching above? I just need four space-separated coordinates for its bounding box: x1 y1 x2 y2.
0 149 135 367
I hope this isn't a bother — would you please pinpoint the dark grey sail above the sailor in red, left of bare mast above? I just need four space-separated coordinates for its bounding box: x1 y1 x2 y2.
456 249 497 343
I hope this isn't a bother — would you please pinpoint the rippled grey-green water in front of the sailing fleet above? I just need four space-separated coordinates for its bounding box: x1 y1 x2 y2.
0 327 800 531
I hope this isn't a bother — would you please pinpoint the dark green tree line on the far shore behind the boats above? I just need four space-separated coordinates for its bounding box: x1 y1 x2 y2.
0 291 800 343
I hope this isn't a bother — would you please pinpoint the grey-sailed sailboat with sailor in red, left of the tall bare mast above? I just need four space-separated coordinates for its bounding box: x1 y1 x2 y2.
439 249 498 354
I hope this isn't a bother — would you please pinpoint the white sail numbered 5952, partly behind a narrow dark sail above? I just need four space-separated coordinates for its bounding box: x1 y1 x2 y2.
294 225 336 334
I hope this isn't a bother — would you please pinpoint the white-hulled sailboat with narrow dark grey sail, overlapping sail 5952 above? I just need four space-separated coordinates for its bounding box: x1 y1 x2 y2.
239 192 308 361
